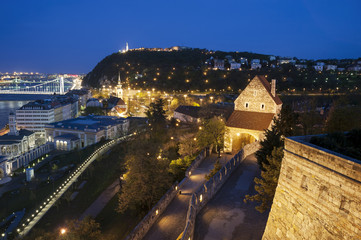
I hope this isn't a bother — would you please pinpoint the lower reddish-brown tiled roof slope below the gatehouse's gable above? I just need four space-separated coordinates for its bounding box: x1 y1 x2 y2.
226 110 274 131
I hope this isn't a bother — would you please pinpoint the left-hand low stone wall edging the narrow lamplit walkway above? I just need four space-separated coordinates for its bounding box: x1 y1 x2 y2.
126 149 209 240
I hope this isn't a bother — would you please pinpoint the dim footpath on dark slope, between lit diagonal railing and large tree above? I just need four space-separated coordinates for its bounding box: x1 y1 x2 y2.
80 179 120 220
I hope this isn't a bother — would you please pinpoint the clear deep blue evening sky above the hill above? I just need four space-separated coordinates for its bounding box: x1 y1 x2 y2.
0 0 361 73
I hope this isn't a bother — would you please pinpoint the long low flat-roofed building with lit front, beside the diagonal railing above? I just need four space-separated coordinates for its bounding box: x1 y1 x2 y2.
45 115 129 151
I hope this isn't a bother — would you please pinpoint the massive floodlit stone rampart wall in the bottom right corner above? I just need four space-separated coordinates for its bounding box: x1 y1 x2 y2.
263 137 361 240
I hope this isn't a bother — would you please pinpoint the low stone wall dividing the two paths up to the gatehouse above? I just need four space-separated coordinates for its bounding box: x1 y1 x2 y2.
179 142 260 240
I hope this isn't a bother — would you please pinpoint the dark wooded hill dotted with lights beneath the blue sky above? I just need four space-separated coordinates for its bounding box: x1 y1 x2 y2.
83 48 361 93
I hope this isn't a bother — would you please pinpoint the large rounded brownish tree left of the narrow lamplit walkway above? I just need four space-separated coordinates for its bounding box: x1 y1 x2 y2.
118 139 171 212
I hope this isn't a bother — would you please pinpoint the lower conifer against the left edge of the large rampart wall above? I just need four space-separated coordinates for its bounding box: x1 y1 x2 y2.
243 147 283 213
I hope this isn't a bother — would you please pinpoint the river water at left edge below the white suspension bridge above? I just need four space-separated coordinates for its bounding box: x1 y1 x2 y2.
0 94 51 129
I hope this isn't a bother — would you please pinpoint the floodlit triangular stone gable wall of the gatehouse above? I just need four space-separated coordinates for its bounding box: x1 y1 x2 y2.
234 78 277 113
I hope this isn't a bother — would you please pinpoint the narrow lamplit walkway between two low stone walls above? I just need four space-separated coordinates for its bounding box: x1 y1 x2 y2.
143 154 232 240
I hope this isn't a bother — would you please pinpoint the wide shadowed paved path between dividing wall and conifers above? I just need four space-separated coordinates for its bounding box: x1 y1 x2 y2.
194 155 268 240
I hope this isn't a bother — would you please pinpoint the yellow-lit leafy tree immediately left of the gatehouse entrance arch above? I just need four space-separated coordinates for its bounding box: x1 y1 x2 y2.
197 117 226 157
